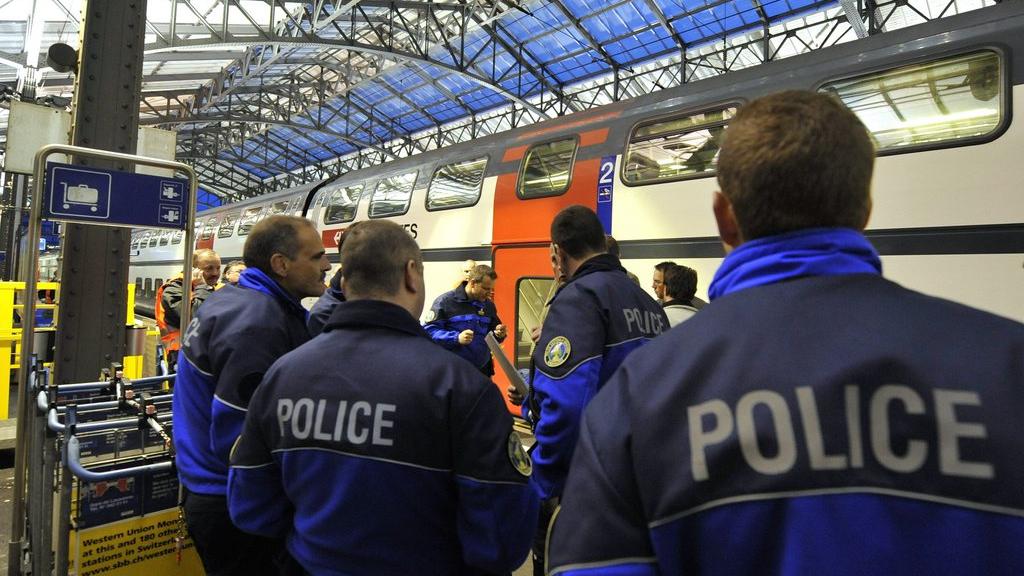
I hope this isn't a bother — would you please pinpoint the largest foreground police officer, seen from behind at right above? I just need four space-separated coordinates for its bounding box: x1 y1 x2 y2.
549 91 1024 576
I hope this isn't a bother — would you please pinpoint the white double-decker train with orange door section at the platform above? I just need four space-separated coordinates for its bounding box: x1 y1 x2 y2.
99 2 1024 403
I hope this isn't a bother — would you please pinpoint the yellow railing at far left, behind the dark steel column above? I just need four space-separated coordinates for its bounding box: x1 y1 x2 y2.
0 282 142 420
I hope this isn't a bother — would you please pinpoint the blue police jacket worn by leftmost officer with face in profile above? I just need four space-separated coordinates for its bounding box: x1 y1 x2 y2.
172 268 309 496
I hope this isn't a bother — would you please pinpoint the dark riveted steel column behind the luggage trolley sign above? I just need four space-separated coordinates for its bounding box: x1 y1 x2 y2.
54 0 146 383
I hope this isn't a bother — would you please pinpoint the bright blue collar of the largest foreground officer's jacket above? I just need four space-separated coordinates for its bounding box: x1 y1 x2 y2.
708 228 882 300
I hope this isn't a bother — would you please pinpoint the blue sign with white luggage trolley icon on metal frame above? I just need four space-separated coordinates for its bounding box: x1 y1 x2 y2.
43 162 191 230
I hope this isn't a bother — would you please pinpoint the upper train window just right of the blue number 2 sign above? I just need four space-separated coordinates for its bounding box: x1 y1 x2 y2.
609 106 736 184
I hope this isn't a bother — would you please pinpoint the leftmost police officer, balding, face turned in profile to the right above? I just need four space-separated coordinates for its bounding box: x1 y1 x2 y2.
173 215 331 576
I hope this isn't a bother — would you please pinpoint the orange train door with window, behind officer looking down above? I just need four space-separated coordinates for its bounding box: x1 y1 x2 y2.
492 243 554 415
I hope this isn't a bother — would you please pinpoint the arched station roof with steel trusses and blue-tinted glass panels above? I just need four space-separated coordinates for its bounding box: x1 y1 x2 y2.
0 0 991 198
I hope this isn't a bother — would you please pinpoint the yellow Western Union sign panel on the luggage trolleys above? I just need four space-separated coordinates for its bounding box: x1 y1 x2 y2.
69 508 204 576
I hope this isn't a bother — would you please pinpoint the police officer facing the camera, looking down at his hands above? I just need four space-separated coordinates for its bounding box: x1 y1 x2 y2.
424 264 508 376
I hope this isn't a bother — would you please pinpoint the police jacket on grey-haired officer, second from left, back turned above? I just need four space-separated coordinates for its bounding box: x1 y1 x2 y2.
228 300 538 576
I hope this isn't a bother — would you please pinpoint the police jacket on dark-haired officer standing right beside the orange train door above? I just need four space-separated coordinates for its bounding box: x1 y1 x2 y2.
524 254 669 498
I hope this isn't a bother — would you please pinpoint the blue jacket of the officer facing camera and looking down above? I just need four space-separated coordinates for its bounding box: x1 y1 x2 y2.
423 282 505 374
